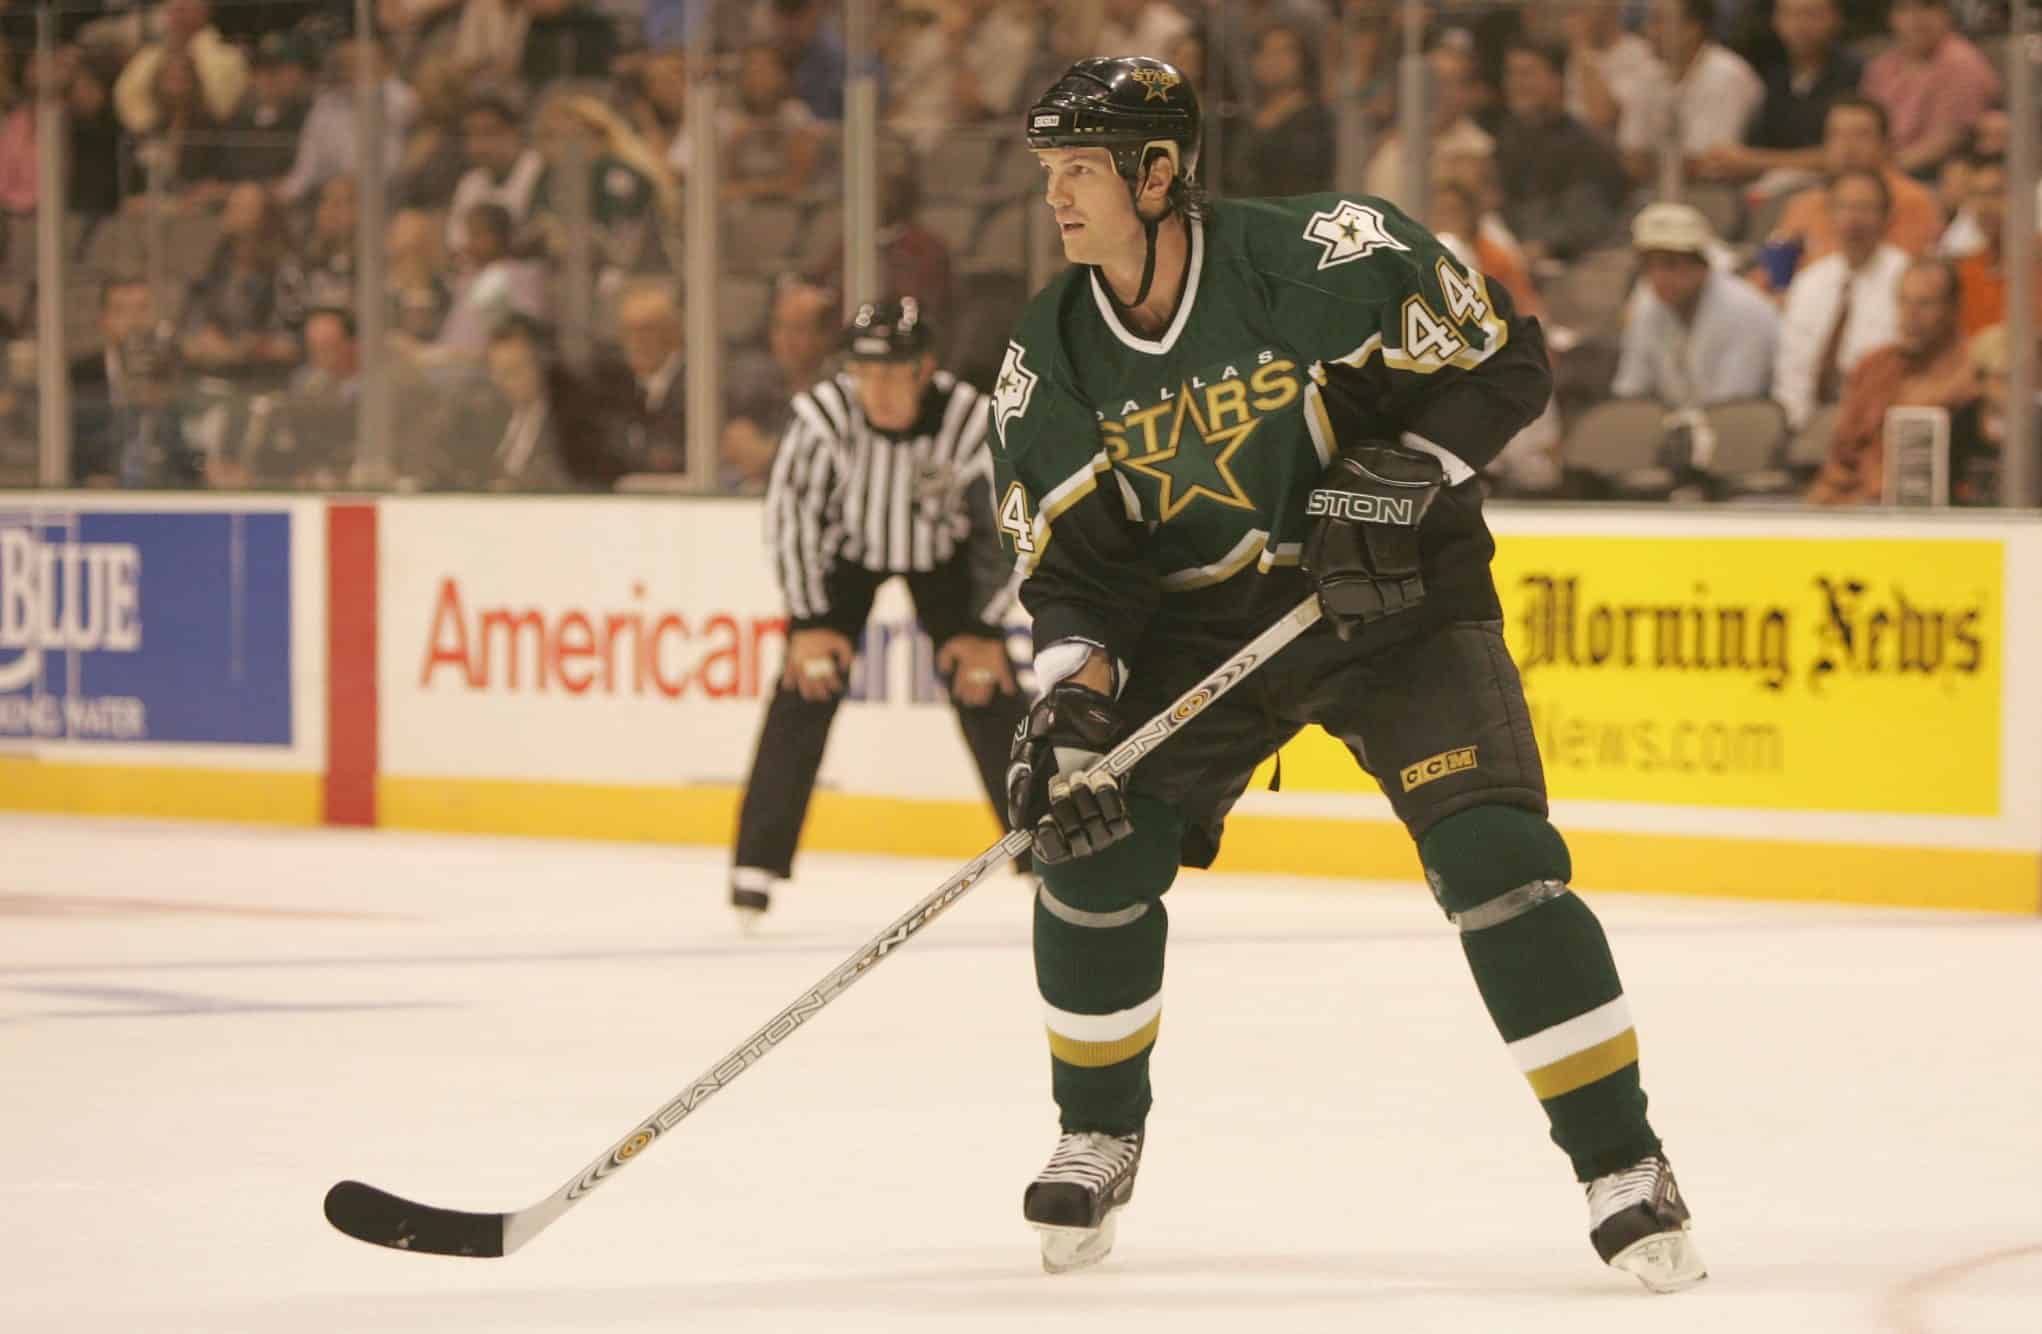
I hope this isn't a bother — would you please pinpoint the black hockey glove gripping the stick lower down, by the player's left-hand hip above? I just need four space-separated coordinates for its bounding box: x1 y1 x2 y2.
1007 680 1135 862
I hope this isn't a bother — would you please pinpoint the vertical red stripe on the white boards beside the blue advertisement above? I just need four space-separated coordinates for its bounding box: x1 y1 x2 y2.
327 505 376 825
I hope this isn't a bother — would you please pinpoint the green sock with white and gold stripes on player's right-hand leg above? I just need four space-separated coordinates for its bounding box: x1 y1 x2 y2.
1419 805 1660 1181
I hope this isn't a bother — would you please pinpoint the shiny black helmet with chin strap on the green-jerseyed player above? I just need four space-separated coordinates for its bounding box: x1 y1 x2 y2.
1027 55 1205 304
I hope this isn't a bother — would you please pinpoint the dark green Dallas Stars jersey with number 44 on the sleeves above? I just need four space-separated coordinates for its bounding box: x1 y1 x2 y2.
990 194 1550 662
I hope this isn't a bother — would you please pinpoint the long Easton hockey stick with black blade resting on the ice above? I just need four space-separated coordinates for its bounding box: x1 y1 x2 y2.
327 597 1319 1256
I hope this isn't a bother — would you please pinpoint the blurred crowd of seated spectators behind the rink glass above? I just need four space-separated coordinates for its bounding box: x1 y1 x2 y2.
0 0 2042 505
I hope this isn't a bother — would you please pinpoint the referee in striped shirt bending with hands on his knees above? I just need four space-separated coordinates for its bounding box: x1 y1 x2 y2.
731 296 1025 923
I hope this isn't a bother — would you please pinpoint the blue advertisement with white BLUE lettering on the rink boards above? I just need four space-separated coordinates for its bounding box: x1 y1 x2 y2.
0 507 292 746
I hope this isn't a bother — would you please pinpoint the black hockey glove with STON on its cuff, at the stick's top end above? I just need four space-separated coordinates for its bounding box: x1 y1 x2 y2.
1305 441 1446 639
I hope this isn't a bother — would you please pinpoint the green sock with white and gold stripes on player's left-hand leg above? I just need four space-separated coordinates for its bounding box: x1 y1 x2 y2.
1035 797 1180 1134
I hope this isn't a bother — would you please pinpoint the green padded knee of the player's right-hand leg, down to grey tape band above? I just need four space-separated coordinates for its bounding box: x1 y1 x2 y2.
1417 805 1574 932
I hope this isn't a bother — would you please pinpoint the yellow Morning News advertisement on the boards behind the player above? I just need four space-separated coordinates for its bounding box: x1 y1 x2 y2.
1282 537 2005 817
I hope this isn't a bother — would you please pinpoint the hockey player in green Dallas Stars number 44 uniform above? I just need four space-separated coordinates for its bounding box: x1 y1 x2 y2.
992 57 1703 1291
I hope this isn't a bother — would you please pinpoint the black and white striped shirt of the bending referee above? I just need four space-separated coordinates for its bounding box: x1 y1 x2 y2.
766 370 992 621
